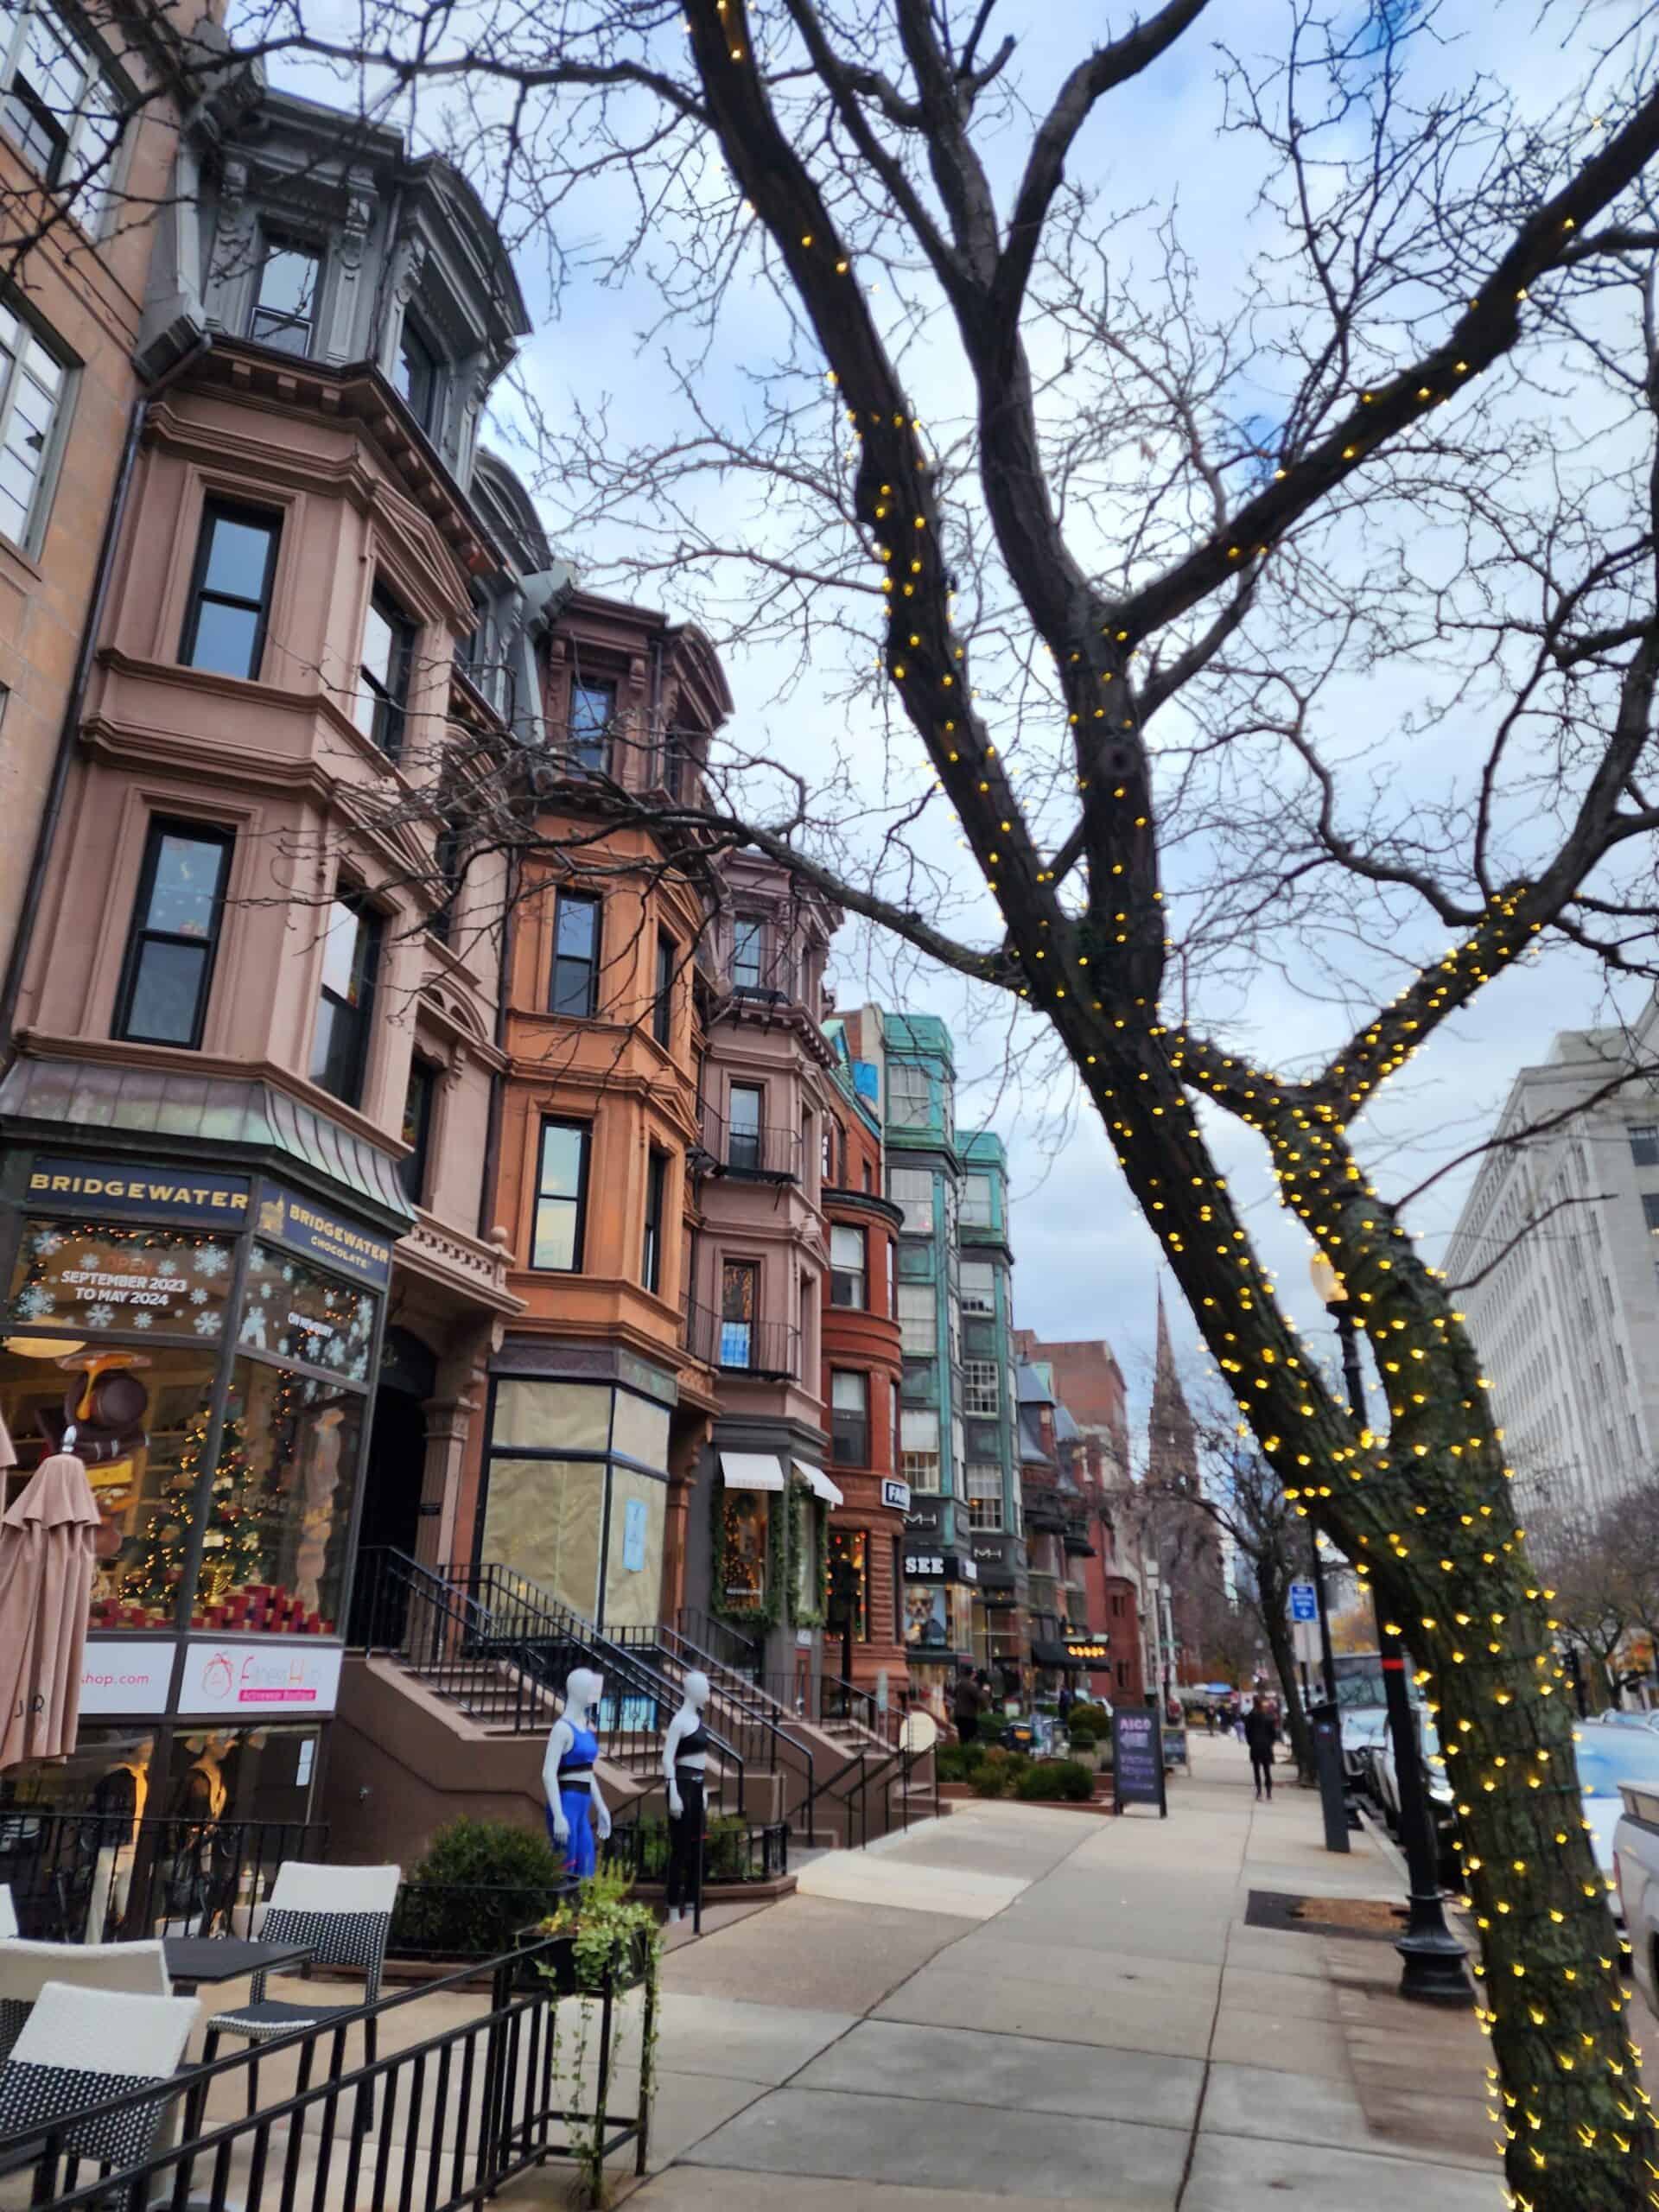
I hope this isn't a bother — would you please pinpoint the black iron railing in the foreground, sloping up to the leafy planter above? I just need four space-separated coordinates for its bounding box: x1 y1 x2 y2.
0 1936 657 2212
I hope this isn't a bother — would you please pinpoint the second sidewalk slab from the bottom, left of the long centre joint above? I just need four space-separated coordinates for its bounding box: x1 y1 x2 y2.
794 2019 1204 2128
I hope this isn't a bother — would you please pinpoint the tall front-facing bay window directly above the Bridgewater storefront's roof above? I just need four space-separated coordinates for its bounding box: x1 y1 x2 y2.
115 821 232 1051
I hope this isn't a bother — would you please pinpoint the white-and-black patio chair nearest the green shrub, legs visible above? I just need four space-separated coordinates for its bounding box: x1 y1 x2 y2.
201 1858 403 2128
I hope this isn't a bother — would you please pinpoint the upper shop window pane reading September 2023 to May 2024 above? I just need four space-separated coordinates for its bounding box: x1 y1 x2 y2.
7 1221 230 1340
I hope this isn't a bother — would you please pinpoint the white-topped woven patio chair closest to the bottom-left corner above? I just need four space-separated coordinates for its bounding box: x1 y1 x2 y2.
0 1982 201 2183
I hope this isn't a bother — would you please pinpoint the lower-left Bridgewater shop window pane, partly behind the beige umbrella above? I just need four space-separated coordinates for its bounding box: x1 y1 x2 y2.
0 1336 214 1628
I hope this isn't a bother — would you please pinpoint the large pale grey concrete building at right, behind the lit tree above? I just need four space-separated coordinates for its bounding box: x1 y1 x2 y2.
1445 1000 1659 1513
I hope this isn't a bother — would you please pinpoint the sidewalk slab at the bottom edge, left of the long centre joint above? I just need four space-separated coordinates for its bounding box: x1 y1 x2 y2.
690 2088 1194 2212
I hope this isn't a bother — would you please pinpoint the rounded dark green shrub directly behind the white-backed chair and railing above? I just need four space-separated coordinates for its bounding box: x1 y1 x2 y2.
387 1818 566 1958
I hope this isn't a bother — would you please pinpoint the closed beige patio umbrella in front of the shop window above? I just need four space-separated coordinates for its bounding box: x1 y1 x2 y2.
0 1451 99 1767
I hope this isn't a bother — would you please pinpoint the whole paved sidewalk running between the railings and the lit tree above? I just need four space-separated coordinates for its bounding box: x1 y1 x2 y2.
526 1738 1530 2212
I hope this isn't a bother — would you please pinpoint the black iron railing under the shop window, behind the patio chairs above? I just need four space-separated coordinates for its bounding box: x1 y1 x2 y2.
0 1805 327 1942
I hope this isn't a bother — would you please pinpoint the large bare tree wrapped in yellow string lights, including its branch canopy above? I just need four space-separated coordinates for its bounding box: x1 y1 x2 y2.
41 0 1659 2212
